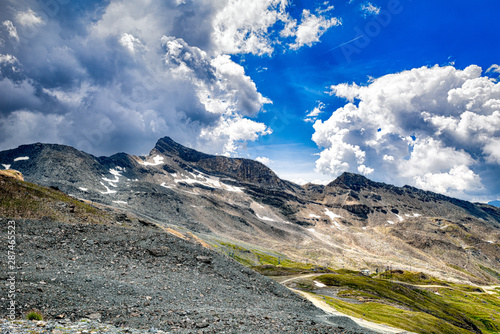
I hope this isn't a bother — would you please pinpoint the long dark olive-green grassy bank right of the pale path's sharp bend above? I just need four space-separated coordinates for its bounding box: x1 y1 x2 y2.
316 274 480 333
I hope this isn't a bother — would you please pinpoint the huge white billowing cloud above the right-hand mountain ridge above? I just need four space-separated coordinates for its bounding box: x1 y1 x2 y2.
313 65 500 199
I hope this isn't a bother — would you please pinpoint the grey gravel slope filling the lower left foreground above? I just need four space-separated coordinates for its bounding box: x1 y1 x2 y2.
0 219 371 333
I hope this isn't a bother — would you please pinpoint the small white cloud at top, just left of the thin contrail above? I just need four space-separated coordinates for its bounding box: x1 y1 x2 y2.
282 9 341 50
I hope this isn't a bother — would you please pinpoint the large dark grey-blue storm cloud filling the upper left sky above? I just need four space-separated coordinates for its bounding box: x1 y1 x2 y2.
0 0 270 155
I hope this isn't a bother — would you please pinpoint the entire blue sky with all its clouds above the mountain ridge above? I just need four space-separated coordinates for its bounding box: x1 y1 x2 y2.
0 0 500 202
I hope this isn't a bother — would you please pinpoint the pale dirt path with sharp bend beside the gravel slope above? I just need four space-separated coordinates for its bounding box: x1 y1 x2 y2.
276 274 412 334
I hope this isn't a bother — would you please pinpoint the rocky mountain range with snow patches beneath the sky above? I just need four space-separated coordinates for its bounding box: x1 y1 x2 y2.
0 137 500 283
